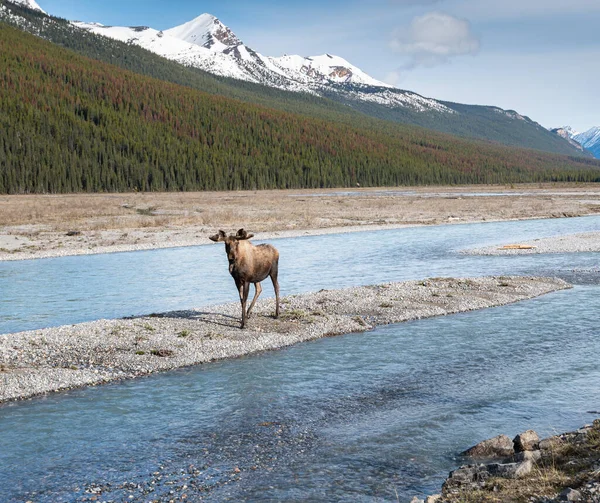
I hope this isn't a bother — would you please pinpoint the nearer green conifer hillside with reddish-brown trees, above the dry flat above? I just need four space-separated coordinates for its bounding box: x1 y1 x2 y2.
0 25 600 193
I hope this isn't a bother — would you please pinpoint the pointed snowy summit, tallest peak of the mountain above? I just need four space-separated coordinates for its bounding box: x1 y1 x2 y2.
164 13 242 52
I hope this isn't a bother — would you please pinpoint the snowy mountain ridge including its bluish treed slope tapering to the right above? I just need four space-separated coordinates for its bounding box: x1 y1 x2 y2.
64 9 584 155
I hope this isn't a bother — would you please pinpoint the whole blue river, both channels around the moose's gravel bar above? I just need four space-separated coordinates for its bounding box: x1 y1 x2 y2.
0 217 600 503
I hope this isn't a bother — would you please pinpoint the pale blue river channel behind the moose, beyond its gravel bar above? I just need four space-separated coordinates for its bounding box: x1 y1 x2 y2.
0 216 600 334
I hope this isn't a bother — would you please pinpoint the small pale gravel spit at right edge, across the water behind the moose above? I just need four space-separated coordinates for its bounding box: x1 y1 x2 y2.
461 232 600 255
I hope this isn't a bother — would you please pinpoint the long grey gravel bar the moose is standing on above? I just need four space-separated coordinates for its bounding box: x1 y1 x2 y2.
0 276 570 402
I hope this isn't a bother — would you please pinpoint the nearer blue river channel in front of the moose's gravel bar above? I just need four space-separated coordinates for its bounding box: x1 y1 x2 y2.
0 286 600 503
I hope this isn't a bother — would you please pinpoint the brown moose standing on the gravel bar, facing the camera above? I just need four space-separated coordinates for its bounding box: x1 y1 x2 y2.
209 229 279 328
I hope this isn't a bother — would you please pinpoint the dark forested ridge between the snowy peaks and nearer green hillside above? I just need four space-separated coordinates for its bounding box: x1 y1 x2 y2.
0 0 585 156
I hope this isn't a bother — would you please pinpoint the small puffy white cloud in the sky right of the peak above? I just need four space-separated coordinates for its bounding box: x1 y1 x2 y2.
390 12 480 69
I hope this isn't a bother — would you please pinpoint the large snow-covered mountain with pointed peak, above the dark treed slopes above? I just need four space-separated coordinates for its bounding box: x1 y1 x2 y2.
73 14 456 114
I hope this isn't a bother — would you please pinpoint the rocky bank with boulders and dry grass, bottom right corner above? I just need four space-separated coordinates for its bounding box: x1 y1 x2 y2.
412 419 600 503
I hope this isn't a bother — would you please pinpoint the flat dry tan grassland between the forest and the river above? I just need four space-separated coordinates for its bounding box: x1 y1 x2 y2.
0 184 600 260
